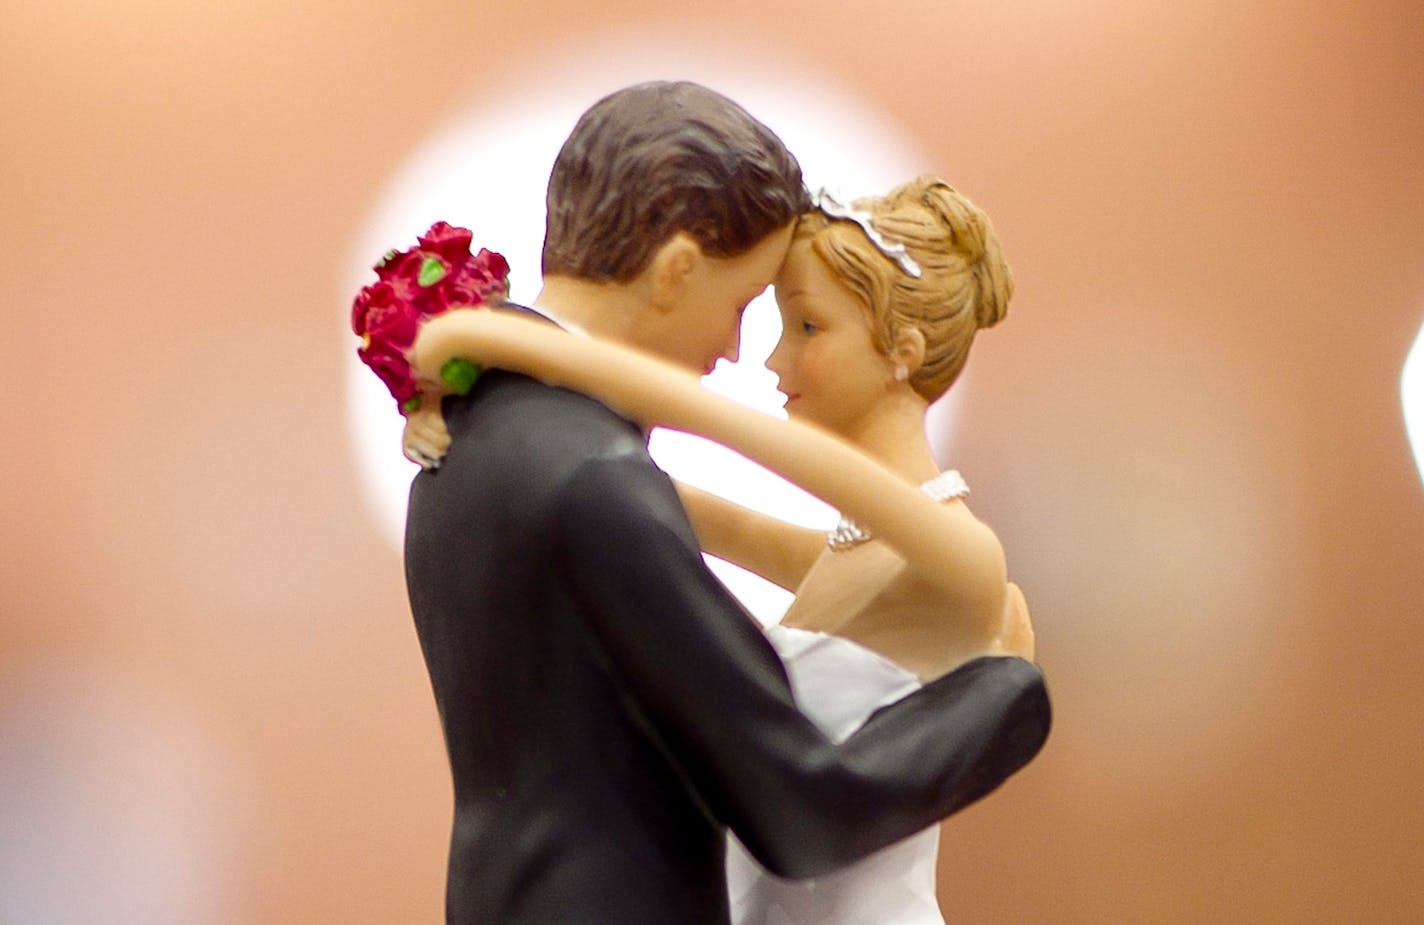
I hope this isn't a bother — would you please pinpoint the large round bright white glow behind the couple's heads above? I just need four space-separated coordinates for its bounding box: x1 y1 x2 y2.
340 34 953 620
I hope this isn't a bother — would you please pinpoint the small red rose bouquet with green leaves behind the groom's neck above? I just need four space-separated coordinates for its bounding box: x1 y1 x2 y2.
352 222 510 414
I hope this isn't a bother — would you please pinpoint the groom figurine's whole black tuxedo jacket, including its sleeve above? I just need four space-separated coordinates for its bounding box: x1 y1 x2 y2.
406 320 1049 925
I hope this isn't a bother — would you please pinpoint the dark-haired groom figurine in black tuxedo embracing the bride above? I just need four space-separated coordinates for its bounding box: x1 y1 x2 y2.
406 84 1049 925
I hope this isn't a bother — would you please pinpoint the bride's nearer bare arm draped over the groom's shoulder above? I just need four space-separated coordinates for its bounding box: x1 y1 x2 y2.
412 309 1005 615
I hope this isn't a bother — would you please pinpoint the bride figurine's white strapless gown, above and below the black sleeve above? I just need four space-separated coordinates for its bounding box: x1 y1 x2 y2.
726 625 944 925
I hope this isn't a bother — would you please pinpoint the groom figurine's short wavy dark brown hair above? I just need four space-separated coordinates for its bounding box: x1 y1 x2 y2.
543 81 810 282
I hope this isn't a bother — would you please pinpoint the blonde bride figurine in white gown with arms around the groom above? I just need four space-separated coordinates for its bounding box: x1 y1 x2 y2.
406 176 1034 925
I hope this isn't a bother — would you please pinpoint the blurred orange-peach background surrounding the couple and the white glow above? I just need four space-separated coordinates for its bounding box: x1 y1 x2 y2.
0 0 1424 925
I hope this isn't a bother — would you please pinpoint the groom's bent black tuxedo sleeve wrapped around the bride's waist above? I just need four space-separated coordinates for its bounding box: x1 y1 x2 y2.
553 457 1049 877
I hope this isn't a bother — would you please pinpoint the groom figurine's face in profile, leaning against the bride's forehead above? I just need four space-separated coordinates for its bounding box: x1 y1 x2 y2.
658 223 792 376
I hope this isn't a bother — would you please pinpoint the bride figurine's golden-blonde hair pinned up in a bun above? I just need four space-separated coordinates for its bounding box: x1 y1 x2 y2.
796 175 1014 401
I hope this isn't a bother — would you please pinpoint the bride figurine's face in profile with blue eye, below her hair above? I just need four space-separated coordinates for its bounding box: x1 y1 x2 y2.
766 241 893 437
